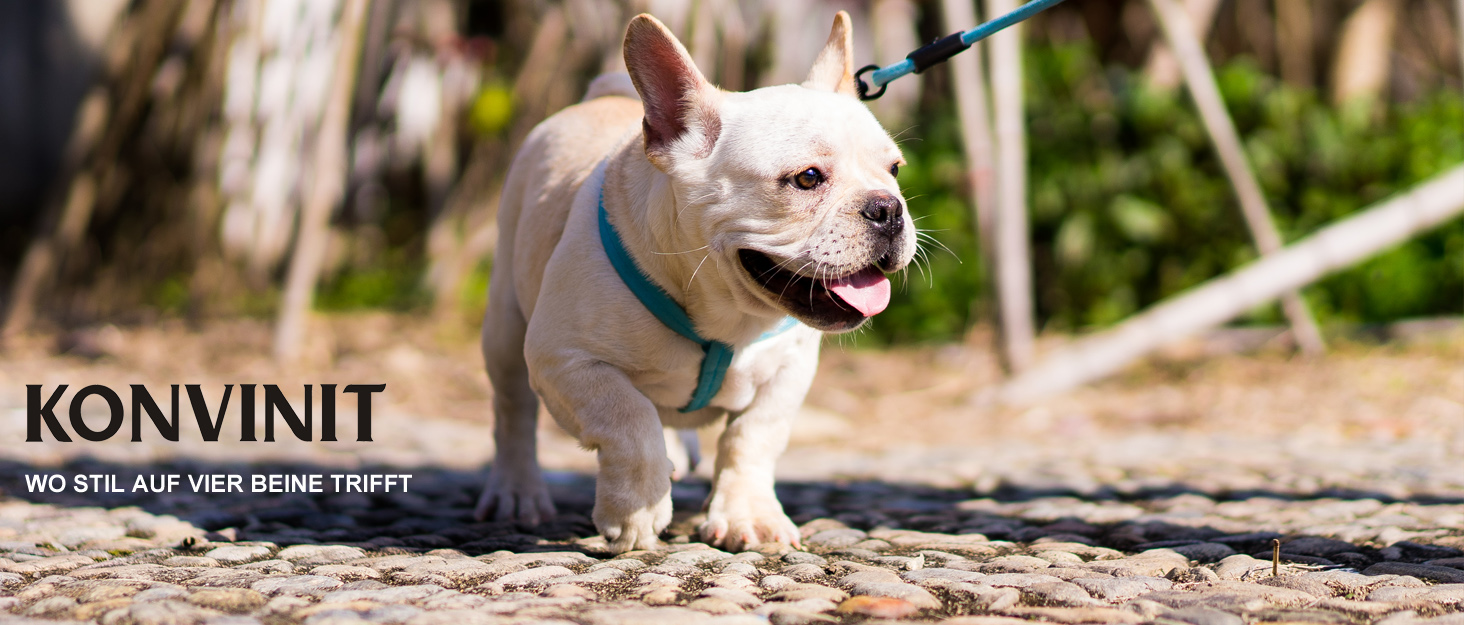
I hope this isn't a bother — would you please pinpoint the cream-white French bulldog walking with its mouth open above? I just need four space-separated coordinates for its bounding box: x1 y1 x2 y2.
477 12 915 552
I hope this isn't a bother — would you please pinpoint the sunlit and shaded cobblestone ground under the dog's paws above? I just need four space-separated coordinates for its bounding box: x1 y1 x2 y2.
0 463 1464 625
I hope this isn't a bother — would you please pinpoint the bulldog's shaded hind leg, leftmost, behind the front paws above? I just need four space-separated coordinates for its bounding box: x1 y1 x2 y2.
474 276 555 524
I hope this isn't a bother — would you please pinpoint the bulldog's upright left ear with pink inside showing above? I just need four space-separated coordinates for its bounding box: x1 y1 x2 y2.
625 13 722 171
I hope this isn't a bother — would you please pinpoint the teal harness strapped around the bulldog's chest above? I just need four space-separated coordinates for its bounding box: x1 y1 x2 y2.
599 183 798 413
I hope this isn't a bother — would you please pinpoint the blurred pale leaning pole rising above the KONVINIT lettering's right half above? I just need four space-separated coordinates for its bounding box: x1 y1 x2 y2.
274 0 370 362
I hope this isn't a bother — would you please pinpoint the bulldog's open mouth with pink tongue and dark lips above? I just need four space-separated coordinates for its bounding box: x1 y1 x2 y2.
738 249 890 329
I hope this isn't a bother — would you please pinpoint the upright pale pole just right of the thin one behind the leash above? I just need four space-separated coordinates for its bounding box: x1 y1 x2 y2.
987 0 1037 372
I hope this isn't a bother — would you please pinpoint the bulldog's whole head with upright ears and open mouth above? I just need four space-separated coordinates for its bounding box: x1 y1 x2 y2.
625 12 915 332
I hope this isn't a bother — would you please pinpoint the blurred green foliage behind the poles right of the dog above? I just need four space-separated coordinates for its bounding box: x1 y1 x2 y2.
861 45 1464 343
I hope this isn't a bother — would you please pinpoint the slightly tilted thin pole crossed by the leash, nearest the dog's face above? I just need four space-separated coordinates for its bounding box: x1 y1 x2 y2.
941 0 1004 352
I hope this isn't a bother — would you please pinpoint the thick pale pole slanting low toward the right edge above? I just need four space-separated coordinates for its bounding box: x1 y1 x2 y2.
1000 165 1464 403
